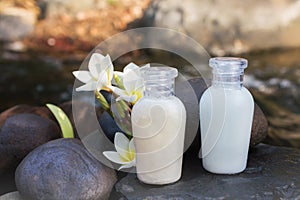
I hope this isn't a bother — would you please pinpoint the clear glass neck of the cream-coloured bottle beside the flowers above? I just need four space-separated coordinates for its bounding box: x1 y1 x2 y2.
143 67 178 98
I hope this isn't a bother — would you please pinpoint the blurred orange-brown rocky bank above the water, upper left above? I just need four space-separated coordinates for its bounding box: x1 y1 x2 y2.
0 0 149 54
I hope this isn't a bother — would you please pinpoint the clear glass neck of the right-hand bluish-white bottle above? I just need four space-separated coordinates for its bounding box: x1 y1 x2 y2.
209 57 247 89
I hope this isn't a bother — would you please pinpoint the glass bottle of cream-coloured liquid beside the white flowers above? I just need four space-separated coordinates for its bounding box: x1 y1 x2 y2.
131 67 186 185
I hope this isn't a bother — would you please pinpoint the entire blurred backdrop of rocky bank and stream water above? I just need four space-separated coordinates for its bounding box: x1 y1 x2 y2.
0 0 300 148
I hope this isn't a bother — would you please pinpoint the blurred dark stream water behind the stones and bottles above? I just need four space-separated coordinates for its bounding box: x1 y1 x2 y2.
0 49 300 148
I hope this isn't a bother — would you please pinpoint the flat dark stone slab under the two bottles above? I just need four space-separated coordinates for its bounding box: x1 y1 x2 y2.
112 144 300 200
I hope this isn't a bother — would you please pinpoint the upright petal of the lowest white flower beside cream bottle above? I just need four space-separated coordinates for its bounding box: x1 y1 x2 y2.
114 132 130 162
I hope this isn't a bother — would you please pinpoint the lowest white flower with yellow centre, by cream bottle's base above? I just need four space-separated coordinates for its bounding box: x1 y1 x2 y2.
103 132 135 170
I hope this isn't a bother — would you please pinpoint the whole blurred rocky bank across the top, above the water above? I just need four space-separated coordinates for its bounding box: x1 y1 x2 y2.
0 0 300 55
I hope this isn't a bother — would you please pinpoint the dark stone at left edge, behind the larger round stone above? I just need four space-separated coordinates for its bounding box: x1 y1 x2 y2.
0 113 61 174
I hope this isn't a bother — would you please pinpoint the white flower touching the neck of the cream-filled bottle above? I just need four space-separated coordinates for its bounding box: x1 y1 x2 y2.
109 63 150 104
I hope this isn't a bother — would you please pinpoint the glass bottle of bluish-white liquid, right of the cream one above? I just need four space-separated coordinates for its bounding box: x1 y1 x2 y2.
199 57 254 174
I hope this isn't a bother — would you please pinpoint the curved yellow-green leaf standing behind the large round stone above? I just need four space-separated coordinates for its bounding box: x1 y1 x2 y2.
46 104 74 138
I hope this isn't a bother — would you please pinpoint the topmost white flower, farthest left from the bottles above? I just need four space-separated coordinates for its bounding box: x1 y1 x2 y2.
73 53 114 91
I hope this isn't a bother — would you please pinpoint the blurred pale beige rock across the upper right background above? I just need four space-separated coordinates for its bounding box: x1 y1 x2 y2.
138 0 300 55
